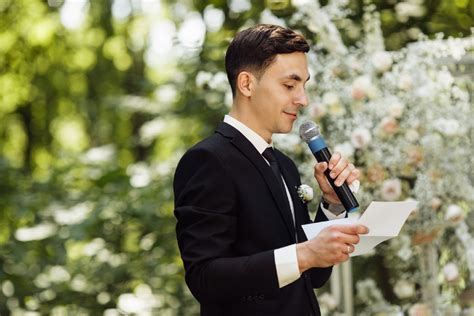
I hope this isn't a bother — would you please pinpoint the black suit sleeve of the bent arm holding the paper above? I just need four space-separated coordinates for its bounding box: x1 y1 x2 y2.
173 148 278 303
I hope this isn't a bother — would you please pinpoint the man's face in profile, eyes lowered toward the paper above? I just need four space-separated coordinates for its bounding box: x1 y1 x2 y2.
250 52 309 138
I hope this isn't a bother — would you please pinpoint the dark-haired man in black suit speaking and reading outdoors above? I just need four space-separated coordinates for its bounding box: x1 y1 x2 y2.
174 25 367 315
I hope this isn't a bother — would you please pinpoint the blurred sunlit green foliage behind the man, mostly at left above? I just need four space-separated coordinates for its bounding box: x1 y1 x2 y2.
0 0 474 315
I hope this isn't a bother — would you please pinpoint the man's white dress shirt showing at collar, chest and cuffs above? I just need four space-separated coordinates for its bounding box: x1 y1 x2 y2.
224 115 352 288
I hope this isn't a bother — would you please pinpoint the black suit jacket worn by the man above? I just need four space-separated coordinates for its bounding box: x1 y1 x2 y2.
174 123 331 316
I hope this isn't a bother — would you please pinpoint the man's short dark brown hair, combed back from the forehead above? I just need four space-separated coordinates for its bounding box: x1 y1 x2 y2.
225 24 309 96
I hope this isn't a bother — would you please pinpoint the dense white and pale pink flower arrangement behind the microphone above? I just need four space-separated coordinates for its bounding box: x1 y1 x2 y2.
268 1 474 315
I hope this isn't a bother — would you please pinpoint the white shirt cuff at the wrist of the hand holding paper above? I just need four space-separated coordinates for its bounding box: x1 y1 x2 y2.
274 244 301 288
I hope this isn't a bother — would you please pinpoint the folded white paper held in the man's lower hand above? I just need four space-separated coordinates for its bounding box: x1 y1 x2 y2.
302 201 418 257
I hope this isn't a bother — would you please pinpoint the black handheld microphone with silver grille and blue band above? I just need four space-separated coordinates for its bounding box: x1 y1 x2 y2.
300 121 359 212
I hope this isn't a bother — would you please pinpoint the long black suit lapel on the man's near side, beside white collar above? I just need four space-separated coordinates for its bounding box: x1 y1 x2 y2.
216 123 295 242
